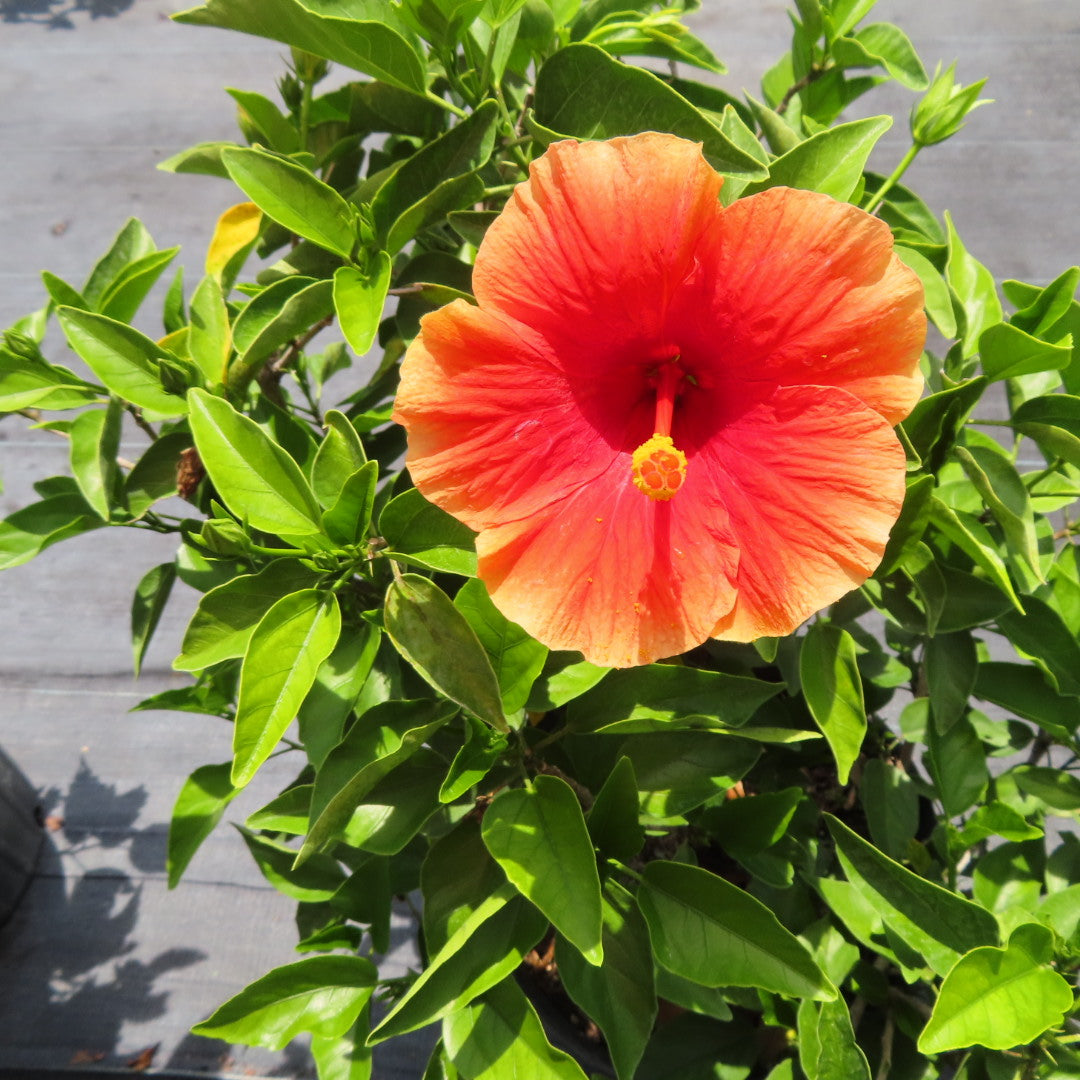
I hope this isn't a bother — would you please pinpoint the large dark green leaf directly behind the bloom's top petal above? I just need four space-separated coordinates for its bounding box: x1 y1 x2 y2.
534 43 765 179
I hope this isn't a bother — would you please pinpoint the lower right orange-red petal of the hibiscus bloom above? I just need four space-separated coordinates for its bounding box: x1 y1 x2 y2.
698 387 905 642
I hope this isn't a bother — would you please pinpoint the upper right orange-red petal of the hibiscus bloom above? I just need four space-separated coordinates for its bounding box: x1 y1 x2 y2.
672 188 927 423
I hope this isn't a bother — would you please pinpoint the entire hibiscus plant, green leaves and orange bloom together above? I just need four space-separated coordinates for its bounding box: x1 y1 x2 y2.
0 0 1080 1080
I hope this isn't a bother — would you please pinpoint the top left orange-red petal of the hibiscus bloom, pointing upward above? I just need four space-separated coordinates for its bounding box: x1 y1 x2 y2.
473 132 721 369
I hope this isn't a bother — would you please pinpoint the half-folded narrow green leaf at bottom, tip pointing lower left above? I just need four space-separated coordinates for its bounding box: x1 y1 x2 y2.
369 881 546 1043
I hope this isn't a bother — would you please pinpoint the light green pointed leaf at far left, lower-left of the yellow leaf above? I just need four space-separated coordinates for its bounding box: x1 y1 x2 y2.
56 308 188 417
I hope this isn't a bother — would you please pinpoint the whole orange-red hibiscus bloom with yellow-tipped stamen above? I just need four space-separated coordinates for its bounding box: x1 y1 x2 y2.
394 133 926 666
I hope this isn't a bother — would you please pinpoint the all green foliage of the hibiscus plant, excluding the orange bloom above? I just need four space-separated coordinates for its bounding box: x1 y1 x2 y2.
0 0 1080 1080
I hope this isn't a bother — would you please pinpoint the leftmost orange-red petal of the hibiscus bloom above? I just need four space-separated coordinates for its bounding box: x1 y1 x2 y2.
393 300 651 530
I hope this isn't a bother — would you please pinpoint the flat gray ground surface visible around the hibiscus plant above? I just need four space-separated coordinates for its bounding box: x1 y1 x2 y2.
0 0 1080 1080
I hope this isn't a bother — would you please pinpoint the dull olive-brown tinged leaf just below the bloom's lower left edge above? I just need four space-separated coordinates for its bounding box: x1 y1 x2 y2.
384 573 508 731
